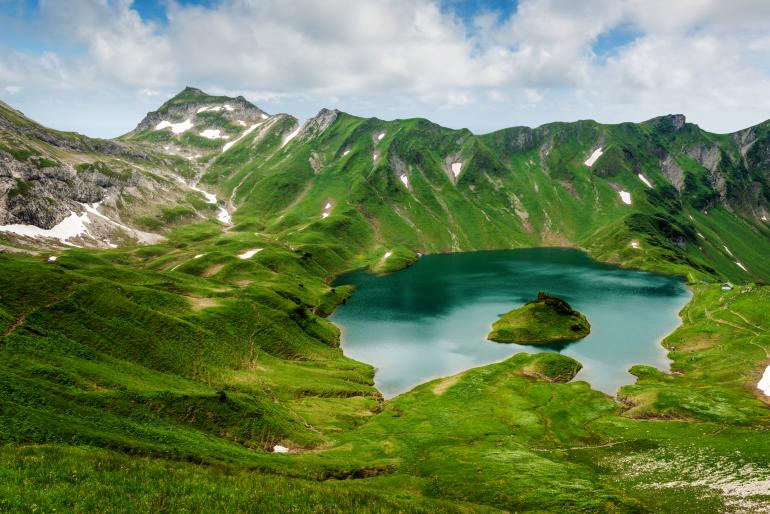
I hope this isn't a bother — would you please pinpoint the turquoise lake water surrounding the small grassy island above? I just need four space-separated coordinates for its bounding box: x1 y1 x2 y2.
331 248 690 398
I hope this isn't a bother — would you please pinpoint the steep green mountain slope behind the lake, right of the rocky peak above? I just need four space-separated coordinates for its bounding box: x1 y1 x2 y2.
196 103 770 281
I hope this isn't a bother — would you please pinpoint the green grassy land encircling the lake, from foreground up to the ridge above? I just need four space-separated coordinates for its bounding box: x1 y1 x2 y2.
0 95 770 512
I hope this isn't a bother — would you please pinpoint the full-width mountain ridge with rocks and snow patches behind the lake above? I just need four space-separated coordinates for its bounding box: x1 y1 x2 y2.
0 87 770 282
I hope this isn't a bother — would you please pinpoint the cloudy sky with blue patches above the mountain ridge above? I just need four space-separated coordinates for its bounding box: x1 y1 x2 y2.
0 0 770 137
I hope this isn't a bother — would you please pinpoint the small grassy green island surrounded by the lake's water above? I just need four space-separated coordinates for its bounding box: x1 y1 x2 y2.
487 292 591 344
